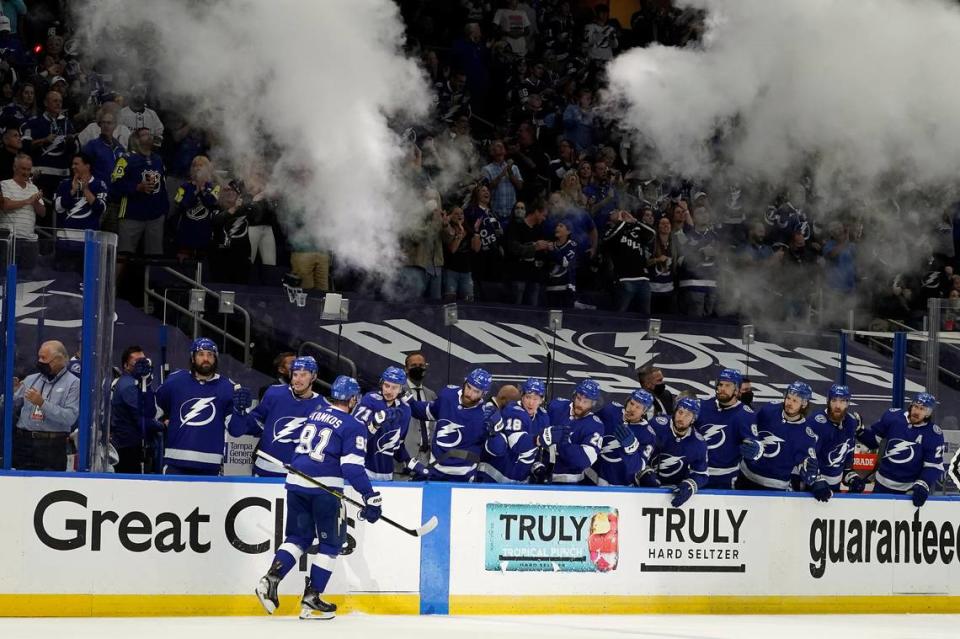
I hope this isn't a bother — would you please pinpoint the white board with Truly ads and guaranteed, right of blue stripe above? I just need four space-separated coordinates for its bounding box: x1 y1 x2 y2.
450 487 960 600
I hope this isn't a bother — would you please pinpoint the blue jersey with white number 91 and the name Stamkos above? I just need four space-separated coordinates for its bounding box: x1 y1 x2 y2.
286 406 373 495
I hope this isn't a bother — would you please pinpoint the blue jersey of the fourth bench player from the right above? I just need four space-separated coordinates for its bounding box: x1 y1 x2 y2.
693 399 757 489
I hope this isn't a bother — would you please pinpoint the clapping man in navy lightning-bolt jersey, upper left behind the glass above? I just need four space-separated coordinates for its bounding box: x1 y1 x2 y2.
53 153 107 272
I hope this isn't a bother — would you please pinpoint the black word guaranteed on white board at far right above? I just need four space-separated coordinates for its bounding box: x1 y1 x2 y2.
810 509 960 579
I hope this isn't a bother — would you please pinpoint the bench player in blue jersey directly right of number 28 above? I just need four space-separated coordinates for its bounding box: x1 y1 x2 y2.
586 388 656 486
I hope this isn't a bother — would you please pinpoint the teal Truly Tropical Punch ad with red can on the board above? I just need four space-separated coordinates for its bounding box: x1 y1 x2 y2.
484 503 620 572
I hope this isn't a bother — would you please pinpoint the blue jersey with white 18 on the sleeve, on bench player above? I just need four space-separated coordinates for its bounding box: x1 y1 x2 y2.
477 402 549 484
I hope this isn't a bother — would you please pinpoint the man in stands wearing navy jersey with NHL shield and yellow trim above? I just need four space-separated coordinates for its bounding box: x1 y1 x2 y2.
111 128 169 255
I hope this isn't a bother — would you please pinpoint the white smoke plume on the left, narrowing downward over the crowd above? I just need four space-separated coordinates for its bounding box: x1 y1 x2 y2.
76 0 431 270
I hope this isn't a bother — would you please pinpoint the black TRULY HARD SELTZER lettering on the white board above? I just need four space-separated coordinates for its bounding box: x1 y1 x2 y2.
640 507 748 573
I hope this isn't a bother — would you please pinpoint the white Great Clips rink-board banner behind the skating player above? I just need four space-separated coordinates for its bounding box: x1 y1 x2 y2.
0 473 421 603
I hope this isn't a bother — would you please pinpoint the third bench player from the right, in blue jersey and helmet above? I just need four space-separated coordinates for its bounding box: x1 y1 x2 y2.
736 381 819 491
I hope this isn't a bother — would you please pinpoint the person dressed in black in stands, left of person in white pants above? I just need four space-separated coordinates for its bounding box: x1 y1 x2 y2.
210 180 250 284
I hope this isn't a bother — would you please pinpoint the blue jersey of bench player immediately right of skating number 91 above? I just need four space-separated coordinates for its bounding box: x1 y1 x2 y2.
353 393 410 481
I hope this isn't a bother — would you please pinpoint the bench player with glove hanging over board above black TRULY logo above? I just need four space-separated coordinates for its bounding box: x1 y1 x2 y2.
634 397 709 508
